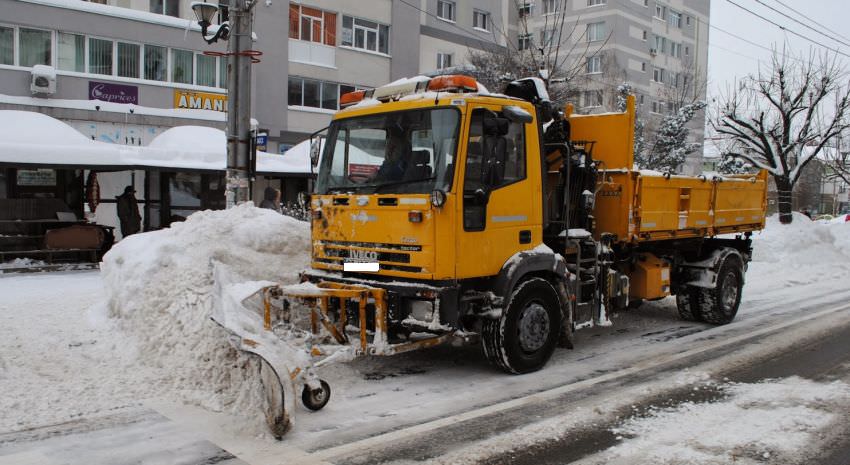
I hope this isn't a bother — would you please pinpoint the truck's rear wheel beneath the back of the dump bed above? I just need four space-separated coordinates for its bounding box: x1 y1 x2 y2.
696 255 744 325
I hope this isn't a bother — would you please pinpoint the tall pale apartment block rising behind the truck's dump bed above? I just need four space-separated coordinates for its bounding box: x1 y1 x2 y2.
511 0 711 174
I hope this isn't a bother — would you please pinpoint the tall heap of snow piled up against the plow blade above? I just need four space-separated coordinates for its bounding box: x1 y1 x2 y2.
101 205 310 421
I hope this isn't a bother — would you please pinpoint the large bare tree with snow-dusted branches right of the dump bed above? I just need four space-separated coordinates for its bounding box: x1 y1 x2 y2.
711 52 850 224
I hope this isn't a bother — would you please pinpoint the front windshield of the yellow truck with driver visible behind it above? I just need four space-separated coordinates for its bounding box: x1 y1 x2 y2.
316 108 460 194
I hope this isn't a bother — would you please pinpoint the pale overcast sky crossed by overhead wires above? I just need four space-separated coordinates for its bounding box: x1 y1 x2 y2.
702 0 850 99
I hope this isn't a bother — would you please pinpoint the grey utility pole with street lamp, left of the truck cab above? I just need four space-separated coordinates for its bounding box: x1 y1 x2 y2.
192 0 256 208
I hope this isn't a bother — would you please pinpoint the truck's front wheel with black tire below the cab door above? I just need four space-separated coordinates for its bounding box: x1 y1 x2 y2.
481 278 561 374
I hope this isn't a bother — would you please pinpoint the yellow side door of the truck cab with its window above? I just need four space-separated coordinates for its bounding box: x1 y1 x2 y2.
456 105 541 279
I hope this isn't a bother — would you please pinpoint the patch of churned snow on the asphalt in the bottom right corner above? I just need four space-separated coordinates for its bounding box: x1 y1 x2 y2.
606 377 850 465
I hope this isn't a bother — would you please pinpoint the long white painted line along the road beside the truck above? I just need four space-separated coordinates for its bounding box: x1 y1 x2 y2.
310 305 850 461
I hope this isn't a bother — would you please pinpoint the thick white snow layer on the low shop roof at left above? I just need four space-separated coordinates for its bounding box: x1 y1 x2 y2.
0 110 310 174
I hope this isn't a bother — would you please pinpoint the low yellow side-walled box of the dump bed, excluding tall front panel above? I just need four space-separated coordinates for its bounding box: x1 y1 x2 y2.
594 170 767 242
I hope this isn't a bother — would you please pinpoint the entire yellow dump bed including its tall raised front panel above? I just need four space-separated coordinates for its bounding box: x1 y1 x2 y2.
566 96 767 242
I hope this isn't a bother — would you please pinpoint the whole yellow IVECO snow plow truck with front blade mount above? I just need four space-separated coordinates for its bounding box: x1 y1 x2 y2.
210 75 767 434
